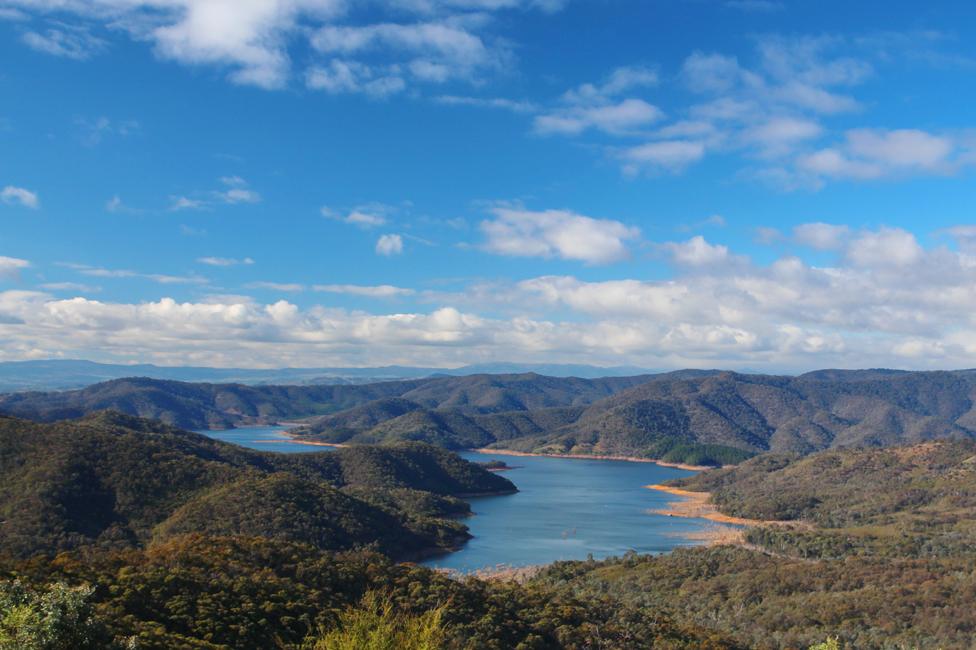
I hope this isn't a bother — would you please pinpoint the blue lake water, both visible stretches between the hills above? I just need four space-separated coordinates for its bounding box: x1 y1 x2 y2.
201 427 713 571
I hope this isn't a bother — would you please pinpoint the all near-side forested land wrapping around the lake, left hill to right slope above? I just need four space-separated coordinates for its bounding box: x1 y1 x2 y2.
0 404 976 650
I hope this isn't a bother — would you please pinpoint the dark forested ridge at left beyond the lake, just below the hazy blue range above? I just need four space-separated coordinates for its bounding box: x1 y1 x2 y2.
0 373 648 429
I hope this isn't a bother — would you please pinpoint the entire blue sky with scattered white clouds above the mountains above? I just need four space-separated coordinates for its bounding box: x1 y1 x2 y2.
0 0 976 372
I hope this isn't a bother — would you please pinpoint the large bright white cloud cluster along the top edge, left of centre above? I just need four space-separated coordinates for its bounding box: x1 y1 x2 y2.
4 0 563 94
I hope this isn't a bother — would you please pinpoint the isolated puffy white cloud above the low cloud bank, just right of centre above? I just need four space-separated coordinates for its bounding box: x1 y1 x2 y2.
481 207 640 264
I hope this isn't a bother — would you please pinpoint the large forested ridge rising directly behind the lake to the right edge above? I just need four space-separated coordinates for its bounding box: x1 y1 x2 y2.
301 370 976 464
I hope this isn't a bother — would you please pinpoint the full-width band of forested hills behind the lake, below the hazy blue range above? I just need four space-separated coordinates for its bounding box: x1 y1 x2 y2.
0 370 976 465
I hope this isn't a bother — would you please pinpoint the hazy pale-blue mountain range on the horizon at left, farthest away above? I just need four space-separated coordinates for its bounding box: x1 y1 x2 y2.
0 359 648 392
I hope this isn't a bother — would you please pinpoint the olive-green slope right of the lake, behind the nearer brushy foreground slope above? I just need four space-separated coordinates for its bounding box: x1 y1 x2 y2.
673 440 976 557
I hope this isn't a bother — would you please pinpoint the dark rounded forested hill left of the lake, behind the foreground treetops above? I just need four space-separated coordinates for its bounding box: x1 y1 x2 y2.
0 412 515 557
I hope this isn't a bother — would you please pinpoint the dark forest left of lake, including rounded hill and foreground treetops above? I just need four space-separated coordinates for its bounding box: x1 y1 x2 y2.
0 412 736 650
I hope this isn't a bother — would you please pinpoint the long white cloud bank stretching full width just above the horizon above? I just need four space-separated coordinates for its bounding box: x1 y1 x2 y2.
0 226 976 371
